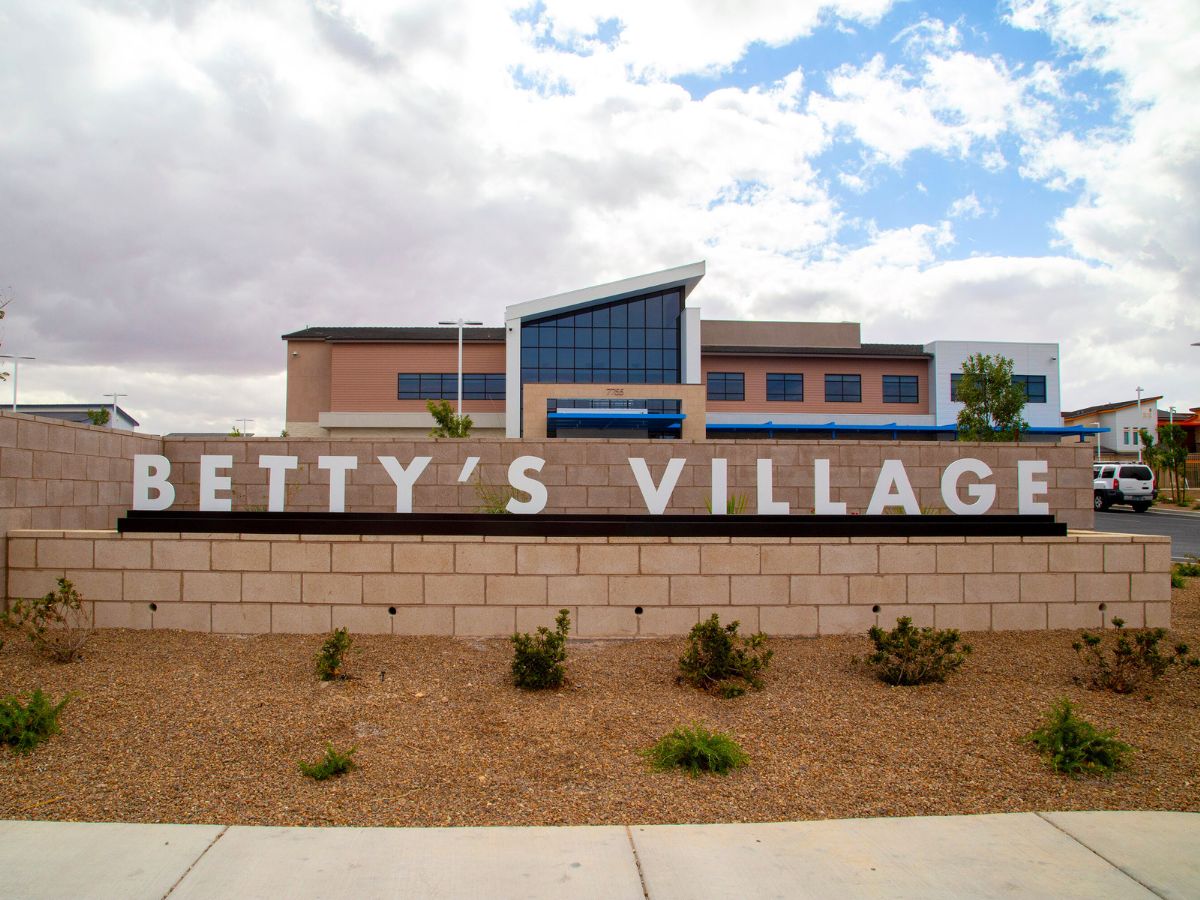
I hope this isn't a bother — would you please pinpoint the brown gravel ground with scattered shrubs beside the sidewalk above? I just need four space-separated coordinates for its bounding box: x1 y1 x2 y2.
0 580 1200 826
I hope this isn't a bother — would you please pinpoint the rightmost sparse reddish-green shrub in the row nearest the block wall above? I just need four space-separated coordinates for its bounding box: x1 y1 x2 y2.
1072 618 1200 694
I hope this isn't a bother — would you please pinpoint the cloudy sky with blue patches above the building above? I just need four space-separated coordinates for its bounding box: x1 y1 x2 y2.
0 0 1200 434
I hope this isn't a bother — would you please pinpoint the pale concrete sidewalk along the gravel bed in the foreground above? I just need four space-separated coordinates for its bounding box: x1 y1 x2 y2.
0 812 1200 900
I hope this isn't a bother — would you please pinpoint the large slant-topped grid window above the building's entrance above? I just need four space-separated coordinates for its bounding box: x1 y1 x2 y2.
521 290 683 384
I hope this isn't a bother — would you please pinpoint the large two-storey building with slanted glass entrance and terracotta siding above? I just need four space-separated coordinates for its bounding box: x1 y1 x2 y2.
283 262 1084 440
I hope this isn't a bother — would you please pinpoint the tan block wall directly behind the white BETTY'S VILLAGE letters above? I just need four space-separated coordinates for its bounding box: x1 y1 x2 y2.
163 438 1094 528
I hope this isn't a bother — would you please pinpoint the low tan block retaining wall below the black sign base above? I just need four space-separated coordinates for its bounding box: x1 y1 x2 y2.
7 529 1170 637
